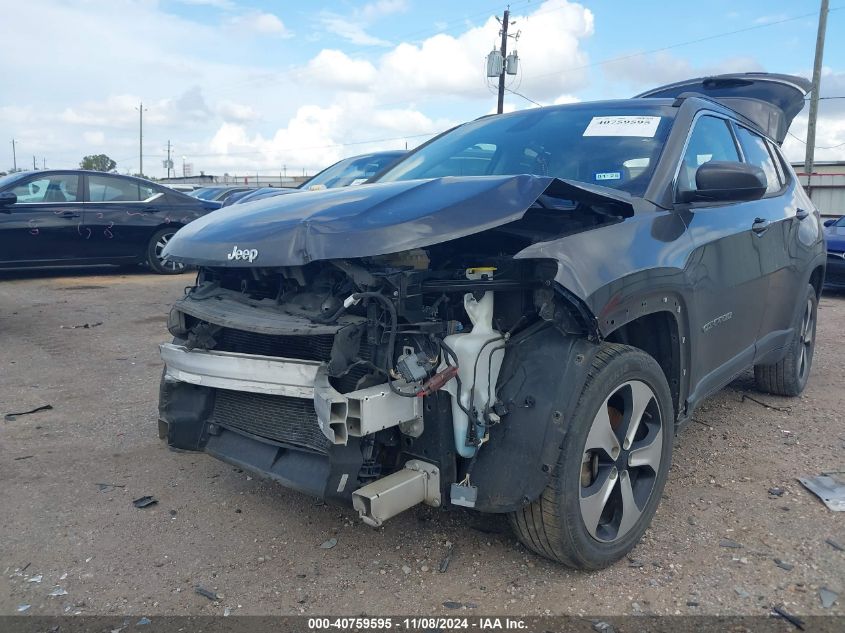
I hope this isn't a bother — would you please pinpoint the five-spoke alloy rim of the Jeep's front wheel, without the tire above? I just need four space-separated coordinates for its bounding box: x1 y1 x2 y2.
580 380 666 543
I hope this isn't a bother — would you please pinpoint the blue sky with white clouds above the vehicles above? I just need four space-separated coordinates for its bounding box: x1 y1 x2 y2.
0 0 845 176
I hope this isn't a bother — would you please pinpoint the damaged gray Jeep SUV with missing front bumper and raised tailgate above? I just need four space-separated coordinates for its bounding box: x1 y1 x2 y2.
159 73 826 569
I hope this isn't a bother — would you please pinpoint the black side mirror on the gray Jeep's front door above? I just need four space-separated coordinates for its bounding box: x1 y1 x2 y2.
679 160 767 202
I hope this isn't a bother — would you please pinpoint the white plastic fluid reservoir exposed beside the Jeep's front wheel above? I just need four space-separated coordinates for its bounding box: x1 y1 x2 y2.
441 292 505 457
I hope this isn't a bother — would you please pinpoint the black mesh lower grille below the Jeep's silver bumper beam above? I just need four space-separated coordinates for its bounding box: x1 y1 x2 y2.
212 389 330 453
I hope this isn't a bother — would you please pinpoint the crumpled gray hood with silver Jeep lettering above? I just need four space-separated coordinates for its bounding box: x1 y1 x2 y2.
164 175 631 267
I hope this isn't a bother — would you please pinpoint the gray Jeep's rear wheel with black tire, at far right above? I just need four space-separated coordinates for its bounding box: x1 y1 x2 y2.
754 284 819 396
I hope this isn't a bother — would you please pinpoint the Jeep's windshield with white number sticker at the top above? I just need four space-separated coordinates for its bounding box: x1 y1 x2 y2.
379 101 674 195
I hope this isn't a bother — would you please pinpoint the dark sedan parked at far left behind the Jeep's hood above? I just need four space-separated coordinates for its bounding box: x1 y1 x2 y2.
0 170 220 274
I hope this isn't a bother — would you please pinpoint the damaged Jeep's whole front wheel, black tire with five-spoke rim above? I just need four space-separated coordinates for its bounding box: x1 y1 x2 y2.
510 344 675 569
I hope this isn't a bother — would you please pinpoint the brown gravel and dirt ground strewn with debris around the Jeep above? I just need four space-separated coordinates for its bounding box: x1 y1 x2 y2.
0 270 845 616
